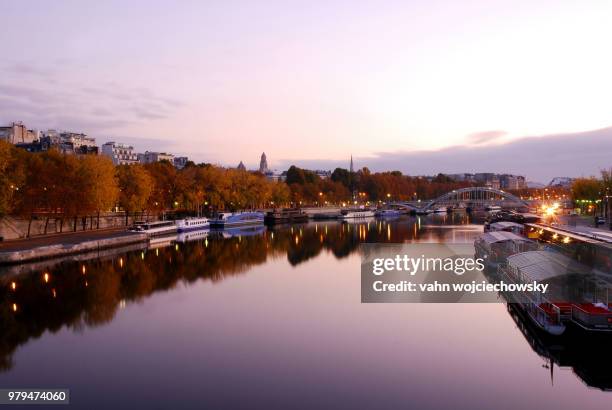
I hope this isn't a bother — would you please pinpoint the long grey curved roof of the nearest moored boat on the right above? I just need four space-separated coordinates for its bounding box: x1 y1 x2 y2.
507 251 591 282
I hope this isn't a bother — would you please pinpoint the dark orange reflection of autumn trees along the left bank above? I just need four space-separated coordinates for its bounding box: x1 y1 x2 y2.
0 219 464 370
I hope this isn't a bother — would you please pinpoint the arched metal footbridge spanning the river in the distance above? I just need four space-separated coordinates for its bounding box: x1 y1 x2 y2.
397 187 528 210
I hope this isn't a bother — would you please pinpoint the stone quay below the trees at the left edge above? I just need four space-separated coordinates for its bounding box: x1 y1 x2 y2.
0 228 147 265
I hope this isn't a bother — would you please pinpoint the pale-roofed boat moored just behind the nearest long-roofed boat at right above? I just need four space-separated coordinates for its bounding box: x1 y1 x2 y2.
474 231 538 268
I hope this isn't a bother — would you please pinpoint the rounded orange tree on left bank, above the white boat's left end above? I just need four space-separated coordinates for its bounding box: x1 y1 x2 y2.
116 164 154 225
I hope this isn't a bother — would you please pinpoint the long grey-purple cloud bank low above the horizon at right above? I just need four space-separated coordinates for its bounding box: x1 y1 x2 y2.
279 127 612 182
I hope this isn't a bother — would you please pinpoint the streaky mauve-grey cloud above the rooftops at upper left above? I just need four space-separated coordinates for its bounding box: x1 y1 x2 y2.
0 62 181 135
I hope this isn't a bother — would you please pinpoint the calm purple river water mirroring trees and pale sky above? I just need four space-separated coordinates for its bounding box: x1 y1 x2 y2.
0 215 612 409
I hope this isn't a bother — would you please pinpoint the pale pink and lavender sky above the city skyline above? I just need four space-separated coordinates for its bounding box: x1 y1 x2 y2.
0 0 612 180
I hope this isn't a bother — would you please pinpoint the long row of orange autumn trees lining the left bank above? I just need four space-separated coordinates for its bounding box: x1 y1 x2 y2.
0 141 468 234
